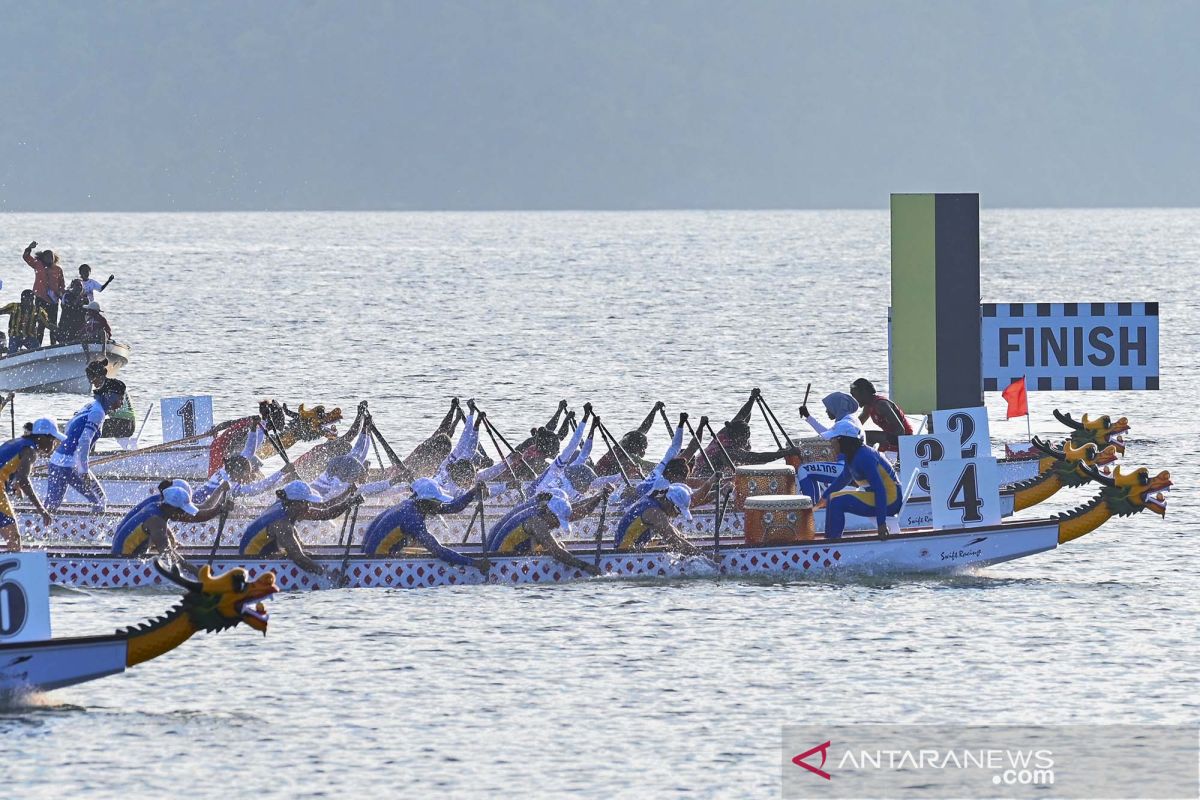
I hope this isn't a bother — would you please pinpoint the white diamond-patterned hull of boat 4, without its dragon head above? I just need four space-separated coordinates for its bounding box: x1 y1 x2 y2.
48 519 1058 591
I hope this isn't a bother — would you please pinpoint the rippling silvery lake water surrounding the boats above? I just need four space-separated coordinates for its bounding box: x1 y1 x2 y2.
0 210 1200 799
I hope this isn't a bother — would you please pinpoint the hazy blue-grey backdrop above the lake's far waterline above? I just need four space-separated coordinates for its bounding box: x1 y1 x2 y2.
0 0 1200 211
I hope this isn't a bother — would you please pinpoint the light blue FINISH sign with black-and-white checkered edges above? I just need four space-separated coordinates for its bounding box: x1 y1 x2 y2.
980 302 1158 392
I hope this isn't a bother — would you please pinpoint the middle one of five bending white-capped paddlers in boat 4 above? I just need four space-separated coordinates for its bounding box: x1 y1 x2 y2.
362 477 487 575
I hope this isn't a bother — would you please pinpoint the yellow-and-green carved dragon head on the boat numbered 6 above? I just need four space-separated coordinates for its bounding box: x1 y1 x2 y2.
155 561 278 633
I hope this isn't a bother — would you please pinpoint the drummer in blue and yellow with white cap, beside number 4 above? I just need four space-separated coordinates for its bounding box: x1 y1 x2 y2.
816 434 904 539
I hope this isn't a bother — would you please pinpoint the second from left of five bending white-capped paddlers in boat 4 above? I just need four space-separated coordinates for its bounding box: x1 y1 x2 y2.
238 481 362 576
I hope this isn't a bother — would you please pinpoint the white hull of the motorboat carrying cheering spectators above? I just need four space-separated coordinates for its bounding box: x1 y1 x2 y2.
0 342 130 395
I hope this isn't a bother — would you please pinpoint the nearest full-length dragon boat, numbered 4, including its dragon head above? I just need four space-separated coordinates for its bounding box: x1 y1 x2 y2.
30 465 1171 591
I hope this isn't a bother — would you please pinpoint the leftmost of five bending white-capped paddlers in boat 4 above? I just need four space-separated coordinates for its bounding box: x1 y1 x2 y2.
112 480 229 572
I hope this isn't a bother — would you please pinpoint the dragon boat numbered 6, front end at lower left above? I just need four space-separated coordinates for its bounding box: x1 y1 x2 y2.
0 555 278 697
